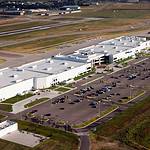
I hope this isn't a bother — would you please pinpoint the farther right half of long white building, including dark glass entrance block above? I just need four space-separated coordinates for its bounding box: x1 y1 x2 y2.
73 36 150 65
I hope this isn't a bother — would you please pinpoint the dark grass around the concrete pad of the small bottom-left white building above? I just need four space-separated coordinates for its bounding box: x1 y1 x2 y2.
0 121 79 150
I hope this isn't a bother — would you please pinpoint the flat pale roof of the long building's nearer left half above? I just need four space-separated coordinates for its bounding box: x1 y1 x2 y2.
0 58 84 88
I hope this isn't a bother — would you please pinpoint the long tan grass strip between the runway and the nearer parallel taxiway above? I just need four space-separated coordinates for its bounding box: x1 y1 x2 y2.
0 18 145 41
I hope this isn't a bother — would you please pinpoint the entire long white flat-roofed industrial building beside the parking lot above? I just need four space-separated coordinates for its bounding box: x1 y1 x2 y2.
0 36 150 101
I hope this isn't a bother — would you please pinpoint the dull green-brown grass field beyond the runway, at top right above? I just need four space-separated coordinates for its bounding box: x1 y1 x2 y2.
69 3 150 19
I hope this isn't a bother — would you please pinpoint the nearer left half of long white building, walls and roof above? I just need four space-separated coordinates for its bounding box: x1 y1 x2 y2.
0 58 91 101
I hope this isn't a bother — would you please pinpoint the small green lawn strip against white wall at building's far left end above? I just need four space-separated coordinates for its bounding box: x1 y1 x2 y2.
2 93 33 104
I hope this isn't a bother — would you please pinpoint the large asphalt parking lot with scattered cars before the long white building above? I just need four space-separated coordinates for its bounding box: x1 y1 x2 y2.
21 58 150 128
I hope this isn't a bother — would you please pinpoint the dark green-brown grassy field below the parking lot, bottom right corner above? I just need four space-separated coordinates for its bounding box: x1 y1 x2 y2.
93 97 150 149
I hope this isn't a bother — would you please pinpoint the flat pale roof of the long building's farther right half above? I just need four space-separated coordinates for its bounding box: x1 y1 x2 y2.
76 36 146 55
